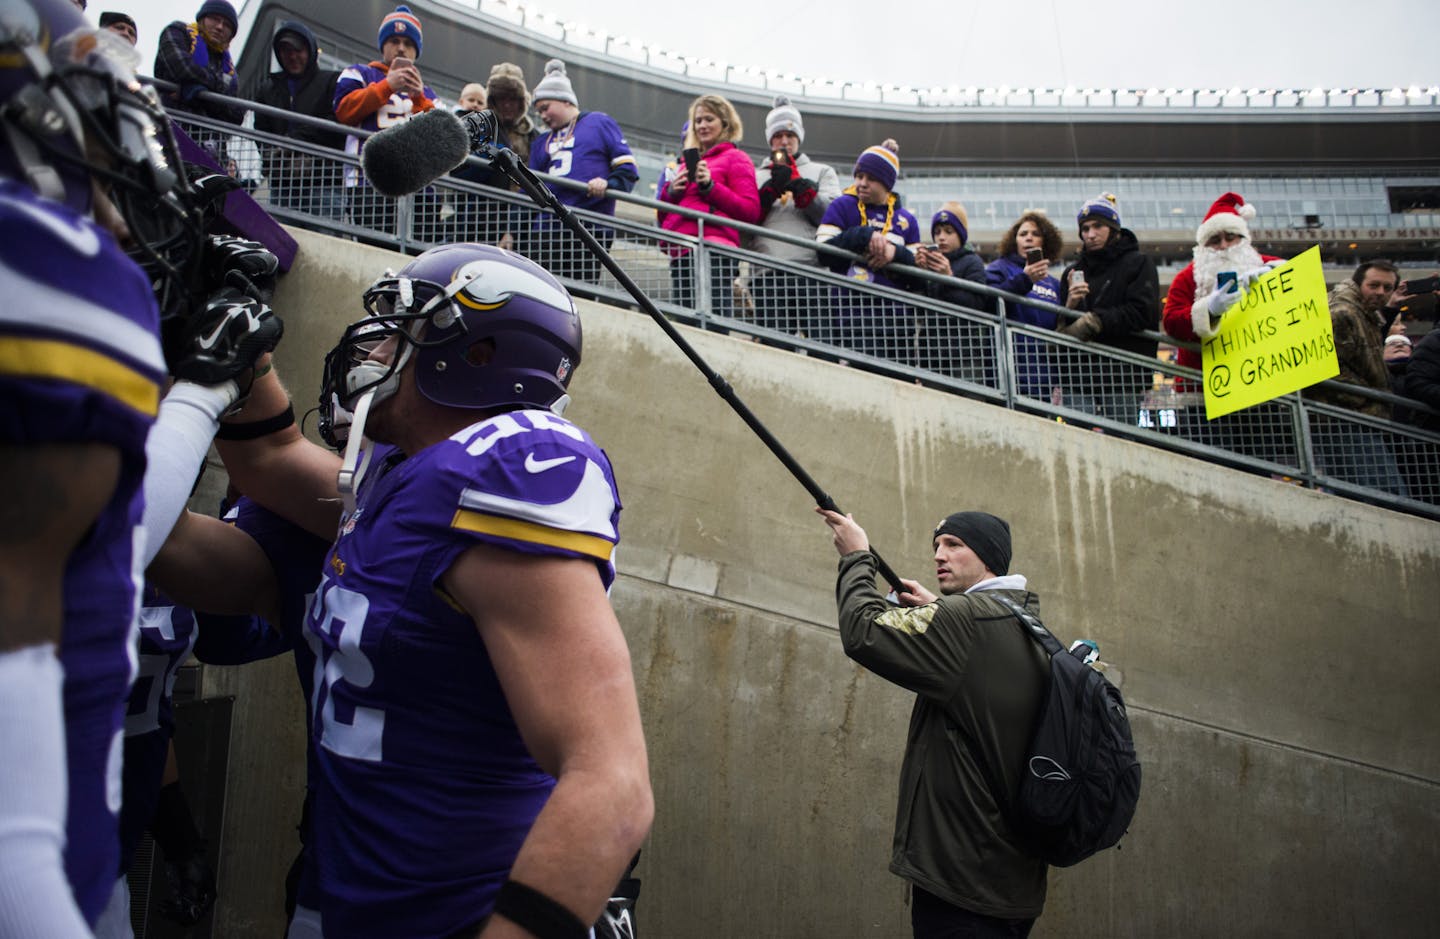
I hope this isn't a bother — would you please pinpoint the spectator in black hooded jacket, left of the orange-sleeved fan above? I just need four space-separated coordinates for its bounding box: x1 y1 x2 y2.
251 20 346 219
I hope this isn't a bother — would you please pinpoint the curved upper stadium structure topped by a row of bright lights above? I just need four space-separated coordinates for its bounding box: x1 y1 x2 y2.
239 0 1440 173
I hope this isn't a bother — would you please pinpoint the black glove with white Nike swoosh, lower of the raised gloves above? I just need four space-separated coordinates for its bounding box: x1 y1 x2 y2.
166 287 285 392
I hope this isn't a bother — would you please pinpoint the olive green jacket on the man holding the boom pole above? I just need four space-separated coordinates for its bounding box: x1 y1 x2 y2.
837 552 1048 919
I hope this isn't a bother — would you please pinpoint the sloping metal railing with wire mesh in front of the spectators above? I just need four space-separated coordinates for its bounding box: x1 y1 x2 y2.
174 105 1440 518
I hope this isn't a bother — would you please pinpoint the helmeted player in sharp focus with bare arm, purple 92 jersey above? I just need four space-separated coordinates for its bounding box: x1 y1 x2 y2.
167 245 654 939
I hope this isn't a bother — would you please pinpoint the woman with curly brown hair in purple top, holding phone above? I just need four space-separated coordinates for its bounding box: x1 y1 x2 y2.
985 212 1064 403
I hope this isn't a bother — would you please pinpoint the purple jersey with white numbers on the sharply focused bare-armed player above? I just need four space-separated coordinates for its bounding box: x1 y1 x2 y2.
307 410 621 939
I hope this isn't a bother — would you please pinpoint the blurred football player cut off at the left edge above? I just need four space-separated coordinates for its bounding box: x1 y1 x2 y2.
0 0 278 936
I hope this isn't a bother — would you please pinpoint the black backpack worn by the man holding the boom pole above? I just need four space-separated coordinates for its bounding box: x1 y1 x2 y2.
995 596 1140 867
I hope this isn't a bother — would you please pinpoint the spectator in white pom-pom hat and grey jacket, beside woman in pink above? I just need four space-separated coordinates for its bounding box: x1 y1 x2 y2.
749 95 840 333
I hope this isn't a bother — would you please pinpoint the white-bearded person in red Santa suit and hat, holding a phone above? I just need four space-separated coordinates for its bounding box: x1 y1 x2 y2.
1162 193 1284 455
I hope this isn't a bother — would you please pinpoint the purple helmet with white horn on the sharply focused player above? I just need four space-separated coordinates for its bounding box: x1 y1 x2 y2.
321 245 580 429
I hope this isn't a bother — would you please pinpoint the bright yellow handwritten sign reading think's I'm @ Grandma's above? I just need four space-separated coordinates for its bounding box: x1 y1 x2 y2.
1201 245 1341 421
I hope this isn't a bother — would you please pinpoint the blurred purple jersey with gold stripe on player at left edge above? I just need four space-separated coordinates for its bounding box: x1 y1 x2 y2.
0 180 166 923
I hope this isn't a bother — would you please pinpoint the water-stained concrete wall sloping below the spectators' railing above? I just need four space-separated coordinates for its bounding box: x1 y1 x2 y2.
206 232 1440 939
